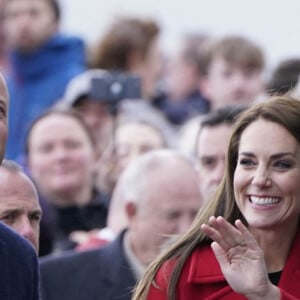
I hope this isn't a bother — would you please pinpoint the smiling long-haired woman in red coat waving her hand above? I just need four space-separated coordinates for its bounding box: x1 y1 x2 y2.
133 96 300 300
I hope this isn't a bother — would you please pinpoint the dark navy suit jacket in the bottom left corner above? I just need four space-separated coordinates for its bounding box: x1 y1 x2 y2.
0 222 39 300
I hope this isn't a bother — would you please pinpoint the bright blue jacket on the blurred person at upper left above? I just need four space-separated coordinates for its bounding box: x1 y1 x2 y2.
6 34 86 160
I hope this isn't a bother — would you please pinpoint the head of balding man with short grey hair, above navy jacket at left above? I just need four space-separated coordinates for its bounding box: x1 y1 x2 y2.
0 160 42 253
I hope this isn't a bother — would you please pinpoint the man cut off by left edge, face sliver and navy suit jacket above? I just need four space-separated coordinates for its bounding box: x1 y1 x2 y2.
0 73 40 300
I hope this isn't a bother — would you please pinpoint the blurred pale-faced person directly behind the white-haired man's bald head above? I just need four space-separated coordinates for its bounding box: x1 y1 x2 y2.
97 112 172 199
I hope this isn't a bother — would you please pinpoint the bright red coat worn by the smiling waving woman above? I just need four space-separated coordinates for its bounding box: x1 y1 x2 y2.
147 233 300 300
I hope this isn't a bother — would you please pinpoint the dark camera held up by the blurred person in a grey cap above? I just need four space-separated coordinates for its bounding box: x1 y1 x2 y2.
89 71 141 104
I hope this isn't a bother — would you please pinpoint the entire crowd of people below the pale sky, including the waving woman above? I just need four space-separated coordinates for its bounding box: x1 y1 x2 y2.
0 0 300 300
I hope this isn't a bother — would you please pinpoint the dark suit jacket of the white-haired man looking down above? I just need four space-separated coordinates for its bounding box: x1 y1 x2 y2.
40 232 136 300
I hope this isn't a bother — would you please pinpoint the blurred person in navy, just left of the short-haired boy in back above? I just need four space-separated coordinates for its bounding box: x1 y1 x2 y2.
159 33 209 125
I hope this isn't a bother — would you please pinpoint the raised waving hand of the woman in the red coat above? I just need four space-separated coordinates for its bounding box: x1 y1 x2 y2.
201 217 280 299
